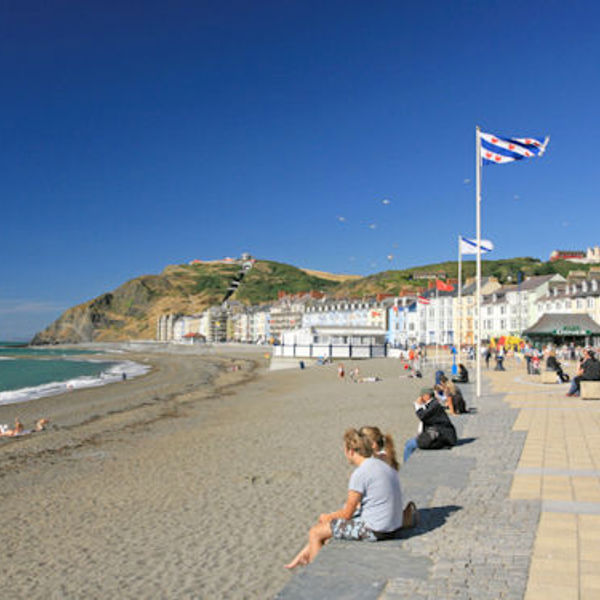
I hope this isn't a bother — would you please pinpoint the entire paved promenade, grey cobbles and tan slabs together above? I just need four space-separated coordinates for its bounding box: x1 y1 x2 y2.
277 364 600 600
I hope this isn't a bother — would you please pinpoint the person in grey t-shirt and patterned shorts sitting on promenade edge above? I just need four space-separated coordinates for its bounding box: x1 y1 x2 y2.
285 429 403 569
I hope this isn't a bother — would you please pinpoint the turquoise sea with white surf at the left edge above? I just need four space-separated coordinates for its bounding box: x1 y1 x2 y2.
0 342 150 405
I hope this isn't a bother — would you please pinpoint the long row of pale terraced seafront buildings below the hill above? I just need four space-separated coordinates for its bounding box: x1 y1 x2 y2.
157 269 600 347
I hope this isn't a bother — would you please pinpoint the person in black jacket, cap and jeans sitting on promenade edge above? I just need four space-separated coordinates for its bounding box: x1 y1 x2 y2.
404 388 457 462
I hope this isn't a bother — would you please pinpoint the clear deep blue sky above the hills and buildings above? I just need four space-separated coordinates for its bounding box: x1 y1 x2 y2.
0 0 600 339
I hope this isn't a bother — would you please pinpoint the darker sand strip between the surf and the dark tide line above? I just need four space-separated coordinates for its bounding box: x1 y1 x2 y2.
0 346 264 477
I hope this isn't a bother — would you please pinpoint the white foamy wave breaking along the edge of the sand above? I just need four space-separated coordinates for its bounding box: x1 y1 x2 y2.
0 359 151 405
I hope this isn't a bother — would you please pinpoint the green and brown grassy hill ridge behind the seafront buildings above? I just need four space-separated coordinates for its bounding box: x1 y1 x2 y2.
32 257 589 344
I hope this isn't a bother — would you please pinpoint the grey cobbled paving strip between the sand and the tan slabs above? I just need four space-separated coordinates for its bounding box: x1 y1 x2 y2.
277 378 541 600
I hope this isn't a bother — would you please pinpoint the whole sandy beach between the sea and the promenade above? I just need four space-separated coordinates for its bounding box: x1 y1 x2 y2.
0 347 422 598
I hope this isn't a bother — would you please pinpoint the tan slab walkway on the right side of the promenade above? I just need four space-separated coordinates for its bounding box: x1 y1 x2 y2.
500 366 600 600
